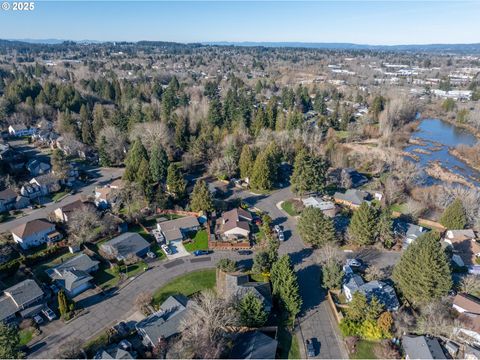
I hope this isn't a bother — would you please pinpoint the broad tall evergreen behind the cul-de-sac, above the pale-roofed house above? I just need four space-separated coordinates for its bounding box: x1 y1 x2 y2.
291 149 328 195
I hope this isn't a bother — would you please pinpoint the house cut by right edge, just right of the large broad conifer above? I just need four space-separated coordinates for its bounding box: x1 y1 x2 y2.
443 229 480 274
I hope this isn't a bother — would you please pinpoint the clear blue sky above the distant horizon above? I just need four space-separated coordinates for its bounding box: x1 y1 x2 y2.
0 0 480 44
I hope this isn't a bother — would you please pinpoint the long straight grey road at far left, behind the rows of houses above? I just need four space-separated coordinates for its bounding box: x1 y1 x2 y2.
0 168 124 233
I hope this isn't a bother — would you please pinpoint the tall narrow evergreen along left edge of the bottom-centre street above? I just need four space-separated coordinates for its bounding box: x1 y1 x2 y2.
270 255 302 318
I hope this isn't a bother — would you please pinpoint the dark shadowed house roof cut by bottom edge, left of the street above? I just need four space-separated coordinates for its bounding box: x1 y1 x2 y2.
229 330 278 359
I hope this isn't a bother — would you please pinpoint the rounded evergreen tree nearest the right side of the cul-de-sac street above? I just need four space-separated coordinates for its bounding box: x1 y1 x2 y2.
298 207 336 247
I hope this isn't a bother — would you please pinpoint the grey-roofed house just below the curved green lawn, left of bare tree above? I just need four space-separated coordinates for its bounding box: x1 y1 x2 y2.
135 295 193 347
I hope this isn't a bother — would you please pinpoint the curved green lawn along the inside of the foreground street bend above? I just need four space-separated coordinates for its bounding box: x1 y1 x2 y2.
153 269 216 305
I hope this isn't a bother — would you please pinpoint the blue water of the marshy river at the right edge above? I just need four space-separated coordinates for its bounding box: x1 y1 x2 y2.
404 119 480 187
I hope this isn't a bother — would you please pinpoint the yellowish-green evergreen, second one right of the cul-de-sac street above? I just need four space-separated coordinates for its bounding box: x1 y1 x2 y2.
348 202 377 245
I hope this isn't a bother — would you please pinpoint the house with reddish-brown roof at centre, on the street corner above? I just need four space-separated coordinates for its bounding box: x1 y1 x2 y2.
215 208 253 239
